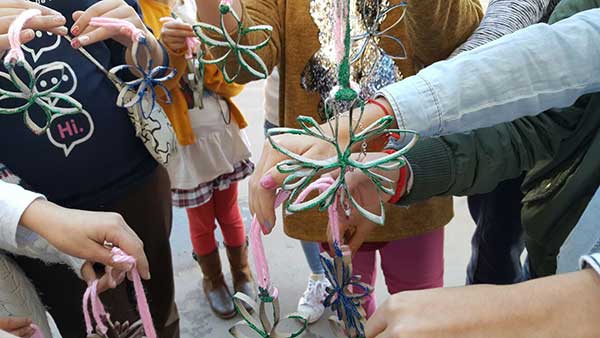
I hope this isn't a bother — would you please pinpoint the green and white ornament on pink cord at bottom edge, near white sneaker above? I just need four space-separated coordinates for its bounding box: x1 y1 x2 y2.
229 218 308 338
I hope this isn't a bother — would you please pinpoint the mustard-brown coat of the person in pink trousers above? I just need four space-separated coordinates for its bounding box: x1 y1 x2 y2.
206 0 483 242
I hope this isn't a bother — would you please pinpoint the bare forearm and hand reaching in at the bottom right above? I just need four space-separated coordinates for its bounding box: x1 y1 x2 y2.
366 269 600 338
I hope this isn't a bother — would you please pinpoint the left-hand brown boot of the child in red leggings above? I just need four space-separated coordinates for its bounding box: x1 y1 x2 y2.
194 249 235 319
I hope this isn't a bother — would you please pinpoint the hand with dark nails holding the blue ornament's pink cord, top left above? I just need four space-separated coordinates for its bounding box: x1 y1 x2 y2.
71 0 153 48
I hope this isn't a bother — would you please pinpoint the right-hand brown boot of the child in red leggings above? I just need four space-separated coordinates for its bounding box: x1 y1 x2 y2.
226 244 256 299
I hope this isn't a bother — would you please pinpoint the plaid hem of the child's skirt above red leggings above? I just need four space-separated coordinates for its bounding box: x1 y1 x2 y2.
171 160 254 208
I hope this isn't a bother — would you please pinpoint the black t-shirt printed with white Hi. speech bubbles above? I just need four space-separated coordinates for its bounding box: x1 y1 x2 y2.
0 0 157 207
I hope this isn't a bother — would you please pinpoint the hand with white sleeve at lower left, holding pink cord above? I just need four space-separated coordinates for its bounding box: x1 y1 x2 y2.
20 200 150 279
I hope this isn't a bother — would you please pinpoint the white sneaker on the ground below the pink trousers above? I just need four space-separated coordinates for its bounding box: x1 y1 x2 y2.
298 274 330 324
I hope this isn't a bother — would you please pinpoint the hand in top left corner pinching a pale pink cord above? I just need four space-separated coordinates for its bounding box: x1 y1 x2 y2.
0 0 68 51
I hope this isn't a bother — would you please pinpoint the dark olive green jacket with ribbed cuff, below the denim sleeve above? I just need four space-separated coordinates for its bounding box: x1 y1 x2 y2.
400 0 600 277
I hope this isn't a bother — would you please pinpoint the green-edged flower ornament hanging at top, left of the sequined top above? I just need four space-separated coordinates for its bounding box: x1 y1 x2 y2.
194 0 273 83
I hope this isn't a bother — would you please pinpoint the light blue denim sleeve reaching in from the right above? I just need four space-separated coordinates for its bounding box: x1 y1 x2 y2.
380 9 600 136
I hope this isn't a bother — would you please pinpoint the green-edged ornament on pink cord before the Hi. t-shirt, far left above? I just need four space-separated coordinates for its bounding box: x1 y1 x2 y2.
0 9 83 135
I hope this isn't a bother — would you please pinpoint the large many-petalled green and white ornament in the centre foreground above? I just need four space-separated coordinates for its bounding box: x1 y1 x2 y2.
267 99 418 225
